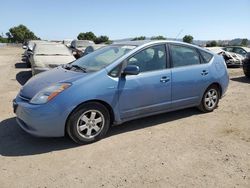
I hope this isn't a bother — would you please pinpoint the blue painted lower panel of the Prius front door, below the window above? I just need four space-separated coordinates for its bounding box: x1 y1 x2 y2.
118 69 171 119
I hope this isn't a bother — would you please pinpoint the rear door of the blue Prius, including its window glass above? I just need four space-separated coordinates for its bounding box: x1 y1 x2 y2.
169 44 211 109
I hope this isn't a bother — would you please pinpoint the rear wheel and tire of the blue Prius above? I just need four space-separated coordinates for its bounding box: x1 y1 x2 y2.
198 85 220 112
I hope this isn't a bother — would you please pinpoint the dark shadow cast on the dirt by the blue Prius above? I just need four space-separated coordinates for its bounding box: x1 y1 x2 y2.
0 108 200 156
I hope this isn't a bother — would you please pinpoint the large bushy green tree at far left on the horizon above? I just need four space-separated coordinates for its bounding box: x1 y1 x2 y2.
6 24 39 43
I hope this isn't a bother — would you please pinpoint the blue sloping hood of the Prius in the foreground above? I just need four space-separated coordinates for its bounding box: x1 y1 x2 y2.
19 66 86 99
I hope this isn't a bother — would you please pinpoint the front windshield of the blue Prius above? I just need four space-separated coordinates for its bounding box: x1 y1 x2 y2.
72 45 136 72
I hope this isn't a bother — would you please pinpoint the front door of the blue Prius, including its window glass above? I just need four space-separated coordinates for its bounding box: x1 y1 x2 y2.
118 44 171 119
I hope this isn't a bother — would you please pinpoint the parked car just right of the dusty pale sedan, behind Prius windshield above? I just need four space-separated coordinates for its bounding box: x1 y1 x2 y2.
70 40 95 59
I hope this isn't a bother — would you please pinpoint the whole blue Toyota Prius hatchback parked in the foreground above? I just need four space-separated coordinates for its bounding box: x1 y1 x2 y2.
13 41 229 144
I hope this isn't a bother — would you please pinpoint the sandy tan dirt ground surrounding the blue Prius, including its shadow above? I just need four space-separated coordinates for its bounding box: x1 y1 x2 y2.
0 47 250 188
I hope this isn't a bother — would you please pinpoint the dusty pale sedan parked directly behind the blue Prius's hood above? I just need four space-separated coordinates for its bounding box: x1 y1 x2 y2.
30 43 75 75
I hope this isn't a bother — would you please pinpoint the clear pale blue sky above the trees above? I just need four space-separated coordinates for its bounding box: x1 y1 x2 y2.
0 0 250 40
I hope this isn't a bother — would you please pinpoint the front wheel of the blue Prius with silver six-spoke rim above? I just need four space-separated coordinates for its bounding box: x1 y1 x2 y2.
66 102 110 144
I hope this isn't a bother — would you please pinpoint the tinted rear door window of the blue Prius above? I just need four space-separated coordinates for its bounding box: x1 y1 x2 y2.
170 45 200 67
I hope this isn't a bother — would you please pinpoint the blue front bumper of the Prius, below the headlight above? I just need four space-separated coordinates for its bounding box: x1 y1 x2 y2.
13 97 67 137
